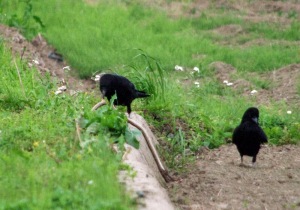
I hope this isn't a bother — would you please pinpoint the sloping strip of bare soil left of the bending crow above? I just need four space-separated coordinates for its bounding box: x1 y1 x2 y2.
0 24 96 91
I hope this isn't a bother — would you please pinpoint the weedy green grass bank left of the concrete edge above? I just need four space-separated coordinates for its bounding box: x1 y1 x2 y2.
0 43 134 209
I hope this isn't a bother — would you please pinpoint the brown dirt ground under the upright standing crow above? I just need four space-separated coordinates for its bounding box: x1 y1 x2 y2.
169 145 300 210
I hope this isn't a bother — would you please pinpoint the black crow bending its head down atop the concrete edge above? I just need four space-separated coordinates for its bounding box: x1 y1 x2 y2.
93 74 150 115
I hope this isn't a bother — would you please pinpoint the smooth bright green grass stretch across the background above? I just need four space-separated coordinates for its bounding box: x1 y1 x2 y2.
2 0 300 77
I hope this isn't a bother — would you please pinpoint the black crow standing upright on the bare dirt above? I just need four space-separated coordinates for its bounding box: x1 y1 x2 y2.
232 107 268 166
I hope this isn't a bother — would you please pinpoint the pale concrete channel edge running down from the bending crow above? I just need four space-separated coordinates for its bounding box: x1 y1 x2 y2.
120 112 175 210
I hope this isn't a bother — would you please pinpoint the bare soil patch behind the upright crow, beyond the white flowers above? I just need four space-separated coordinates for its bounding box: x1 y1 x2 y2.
210 62 300 105
